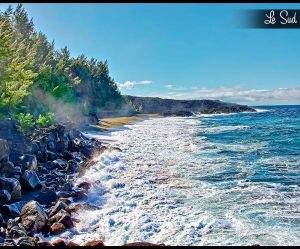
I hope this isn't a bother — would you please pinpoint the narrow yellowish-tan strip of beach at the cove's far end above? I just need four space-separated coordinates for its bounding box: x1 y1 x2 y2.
98 114 161 131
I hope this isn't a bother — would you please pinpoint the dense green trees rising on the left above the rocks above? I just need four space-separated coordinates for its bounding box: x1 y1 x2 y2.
0 4 128 120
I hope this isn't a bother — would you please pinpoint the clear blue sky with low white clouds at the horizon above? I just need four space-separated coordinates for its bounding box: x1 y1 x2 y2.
0 3 300 105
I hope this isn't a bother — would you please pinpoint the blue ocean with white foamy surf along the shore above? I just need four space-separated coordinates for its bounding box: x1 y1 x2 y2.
56 106 300 245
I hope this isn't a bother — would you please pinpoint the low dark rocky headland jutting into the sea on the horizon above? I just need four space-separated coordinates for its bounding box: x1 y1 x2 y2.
126 95 255 116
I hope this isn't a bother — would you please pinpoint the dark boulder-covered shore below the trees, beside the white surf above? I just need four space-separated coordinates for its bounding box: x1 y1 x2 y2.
0 119 169 246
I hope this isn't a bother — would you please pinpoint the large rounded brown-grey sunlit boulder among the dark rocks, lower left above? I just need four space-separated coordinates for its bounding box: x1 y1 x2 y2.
21 201 48 232
